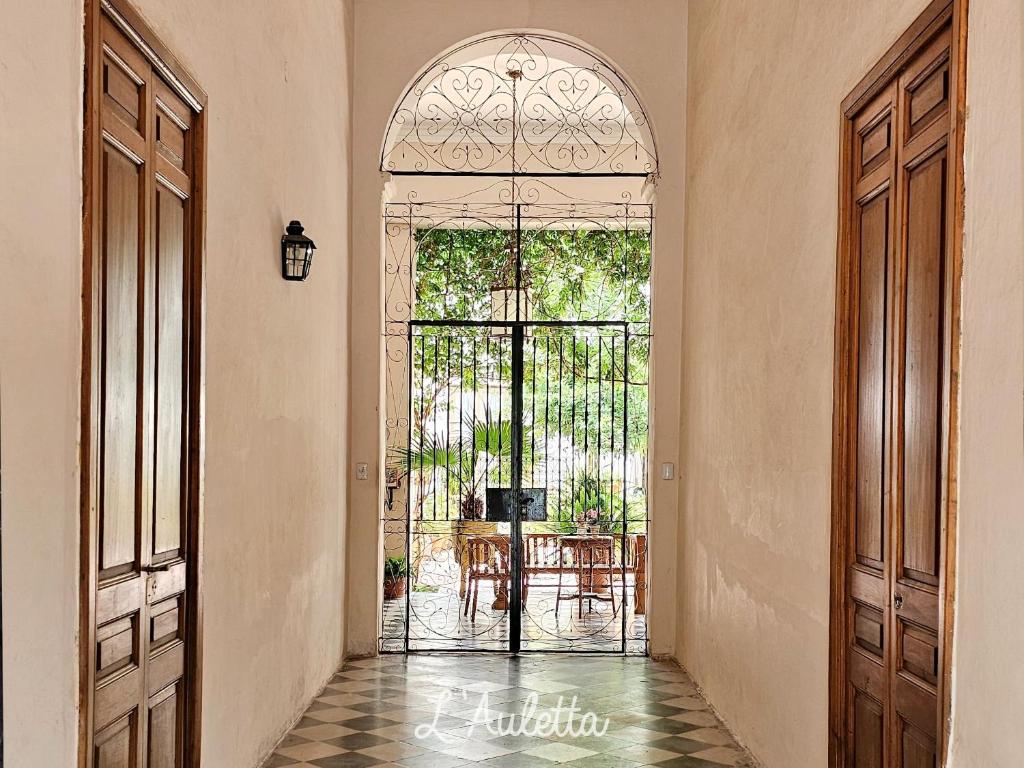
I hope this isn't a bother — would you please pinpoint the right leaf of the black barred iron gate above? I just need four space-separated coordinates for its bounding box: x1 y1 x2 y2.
520 324 634 653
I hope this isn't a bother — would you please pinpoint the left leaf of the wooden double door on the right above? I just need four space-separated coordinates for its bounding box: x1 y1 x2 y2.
847 82 897 768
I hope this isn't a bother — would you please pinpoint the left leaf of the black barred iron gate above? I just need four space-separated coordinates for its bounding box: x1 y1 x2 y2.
399 326 513 650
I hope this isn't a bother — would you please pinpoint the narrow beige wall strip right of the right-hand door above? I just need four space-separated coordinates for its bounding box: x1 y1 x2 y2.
950 0 1024 768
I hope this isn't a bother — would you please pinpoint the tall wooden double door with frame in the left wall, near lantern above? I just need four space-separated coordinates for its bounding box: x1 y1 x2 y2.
82 3 202 768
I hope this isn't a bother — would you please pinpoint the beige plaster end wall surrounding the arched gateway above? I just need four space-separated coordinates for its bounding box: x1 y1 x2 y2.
347 0 686 654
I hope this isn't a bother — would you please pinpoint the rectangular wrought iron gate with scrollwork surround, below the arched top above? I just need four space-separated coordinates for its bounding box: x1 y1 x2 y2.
381 198 650 654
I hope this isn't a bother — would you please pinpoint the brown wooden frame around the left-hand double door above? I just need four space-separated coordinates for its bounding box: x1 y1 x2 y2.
78 0 208 768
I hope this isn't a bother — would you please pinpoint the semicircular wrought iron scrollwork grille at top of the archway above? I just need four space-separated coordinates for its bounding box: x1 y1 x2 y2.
381 33 657 176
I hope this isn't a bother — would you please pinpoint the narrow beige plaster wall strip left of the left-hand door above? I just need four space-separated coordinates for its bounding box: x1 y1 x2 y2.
0 0 83 768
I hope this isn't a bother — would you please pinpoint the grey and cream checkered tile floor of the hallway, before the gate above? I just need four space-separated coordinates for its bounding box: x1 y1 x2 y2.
264 655 753 768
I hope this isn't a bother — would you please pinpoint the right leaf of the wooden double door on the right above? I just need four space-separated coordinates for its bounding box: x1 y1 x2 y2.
890 29 952 768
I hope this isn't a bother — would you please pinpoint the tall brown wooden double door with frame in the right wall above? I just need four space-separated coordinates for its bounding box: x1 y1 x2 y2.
830 2 963 768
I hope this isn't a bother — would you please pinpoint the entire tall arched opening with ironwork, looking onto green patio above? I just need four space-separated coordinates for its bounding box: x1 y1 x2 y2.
380 33 657 654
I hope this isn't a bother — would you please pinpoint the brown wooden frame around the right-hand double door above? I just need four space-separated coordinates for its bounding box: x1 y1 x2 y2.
828 0 969 768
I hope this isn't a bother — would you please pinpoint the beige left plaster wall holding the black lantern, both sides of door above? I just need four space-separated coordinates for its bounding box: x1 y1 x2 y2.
0 0 351 768
